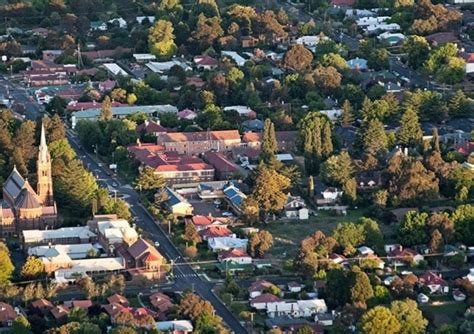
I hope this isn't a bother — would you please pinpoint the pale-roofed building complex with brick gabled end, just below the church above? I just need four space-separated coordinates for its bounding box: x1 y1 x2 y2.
21 215 166 283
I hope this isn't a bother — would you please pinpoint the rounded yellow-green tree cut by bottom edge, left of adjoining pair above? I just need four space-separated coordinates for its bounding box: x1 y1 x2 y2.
360 306 401 334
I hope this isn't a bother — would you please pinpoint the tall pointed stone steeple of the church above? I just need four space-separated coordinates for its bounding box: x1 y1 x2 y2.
36 124 54 206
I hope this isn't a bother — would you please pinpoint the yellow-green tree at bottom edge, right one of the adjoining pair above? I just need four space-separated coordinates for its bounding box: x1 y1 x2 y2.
390 299 428 334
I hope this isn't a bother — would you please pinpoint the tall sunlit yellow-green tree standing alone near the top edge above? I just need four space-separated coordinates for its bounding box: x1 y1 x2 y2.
148 20 178 59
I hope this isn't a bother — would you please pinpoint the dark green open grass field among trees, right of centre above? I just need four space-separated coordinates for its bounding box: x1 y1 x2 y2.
261 209 394 258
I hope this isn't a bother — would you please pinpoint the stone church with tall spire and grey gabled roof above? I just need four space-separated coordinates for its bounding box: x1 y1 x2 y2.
0 125 57 237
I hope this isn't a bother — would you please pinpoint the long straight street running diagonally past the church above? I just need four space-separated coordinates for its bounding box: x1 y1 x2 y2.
0 76 247 334
